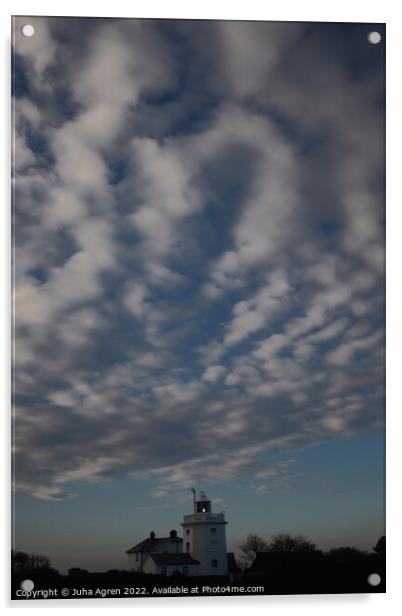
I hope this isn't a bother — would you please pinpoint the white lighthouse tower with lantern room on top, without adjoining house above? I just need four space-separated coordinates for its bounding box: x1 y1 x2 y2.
182 491 228 575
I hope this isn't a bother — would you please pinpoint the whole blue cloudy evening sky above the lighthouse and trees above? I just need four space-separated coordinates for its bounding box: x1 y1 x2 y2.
13 17 385 570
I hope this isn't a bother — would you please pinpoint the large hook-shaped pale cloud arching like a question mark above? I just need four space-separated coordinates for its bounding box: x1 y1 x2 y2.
187 105 297 295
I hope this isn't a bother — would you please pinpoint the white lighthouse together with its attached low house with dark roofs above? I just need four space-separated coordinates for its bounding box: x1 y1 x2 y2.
127 490 233 576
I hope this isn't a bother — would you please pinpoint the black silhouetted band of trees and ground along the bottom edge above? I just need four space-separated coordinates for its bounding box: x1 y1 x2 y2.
11 534 386 594
